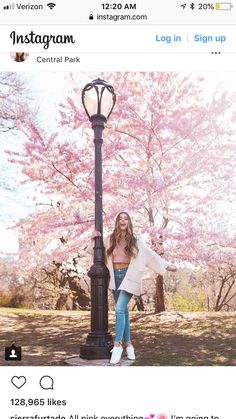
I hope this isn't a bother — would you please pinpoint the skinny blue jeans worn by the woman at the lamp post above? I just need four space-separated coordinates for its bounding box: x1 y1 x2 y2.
113 268 133 343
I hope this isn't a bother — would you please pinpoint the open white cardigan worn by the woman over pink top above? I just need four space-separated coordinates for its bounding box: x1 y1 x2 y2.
87 236 169 295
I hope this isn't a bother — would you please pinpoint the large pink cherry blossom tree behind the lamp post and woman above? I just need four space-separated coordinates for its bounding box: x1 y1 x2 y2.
6 73 236 312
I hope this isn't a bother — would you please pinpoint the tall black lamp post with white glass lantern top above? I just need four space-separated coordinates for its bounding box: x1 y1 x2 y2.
80 79 116 359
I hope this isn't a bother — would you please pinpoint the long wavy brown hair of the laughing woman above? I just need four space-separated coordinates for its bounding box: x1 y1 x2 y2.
107 211 139 257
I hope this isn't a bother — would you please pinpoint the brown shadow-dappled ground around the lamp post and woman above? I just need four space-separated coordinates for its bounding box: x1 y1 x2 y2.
0 308 236 365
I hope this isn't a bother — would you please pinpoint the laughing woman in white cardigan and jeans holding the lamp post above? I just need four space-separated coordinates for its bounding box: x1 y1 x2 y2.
90 212 177 364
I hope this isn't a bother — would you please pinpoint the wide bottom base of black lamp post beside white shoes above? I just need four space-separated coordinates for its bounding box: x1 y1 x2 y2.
80 332 114 359
